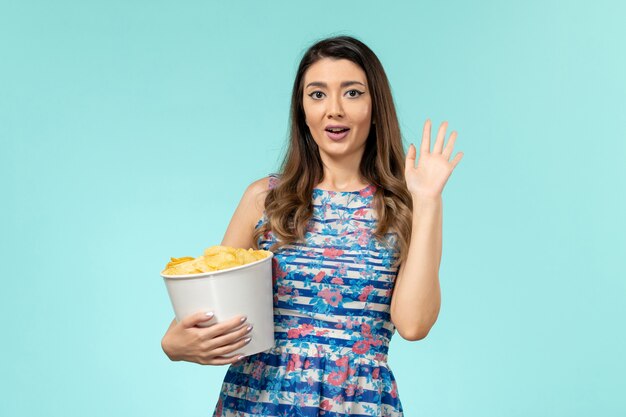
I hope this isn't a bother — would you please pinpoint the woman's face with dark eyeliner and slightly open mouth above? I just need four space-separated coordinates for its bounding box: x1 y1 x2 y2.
302 58 372 160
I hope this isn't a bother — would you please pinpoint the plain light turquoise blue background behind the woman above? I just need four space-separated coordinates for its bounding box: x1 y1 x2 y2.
0 0 626 417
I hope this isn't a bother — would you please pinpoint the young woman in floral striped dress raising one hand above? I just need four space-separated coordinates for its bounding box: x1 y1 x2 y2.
162 36 462 417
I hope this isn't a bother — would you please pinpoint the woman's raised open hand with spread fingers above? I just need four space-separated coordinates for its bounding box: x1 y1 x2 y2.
404 119 463 200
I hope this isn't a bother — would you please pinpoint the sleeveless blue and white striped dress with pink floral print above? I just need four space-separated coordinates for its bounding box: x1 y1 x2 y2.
213 176 403 417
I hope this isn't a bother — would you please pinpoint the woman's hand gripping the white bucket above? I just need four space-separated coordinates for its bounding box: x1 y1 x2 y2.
161 312 252 365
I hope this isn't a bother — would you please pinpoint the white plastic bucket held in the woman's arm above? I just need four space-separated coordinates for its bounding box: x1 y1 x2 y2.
161 254 274 356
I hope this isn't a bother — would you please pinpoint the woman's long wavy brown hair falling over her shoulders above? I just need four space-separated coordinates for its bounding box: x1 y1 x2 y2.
254 36 413 264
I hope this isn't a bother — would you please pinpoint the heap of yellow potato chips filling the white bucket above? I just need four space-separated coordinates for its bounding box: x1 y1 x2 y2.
163 245 271 275
